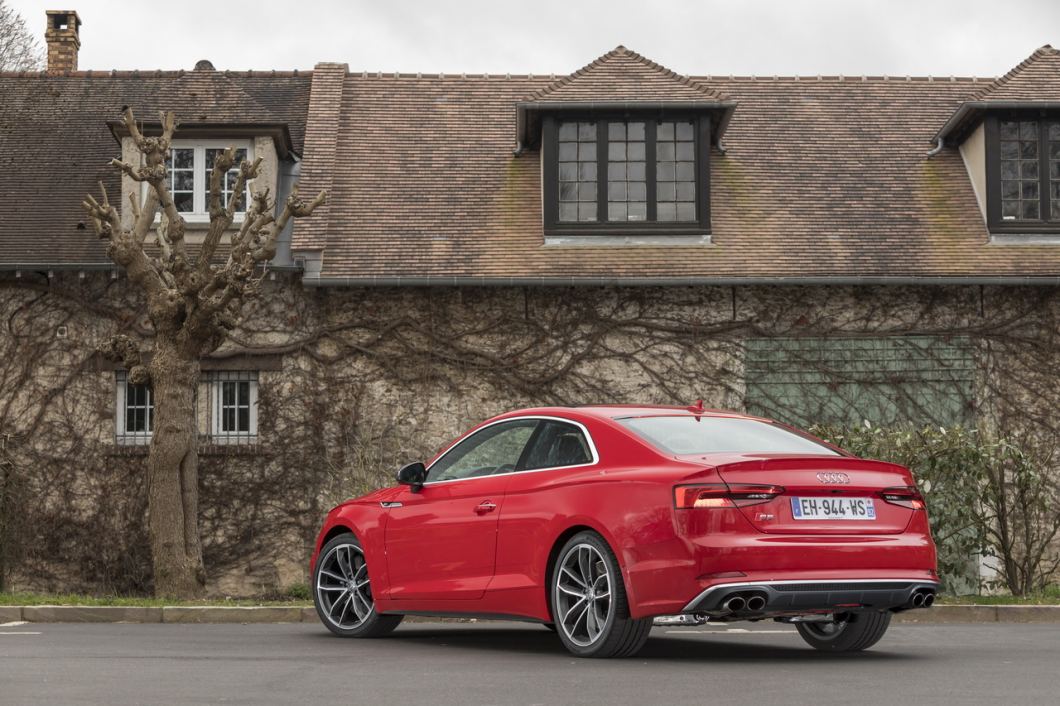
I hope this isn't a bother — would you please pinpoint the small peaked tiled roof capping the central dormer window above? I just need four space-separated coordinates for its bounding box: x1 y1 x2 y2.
528 46 725 103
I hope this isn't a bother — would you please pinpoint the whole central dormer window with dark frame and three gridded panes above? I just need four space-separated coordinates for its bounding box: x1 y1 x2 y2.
542 113 710 235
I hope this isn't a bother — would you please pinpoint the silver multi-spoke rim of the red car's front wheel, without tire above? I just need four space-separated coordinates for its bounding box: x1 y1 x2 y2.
316 544 375 630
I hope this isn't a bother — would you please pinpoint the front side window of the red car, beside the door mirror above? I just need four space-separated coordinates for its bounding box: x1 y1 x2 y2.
427 419 538 482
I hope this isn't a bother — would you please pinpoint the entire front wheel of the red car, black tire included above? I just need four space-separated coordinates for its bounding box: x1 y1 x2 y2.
313 532 405 637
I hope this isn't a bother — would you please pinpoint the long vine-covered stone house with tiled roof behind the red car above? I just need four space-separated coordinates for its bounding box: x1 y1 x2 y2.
0 13 1060 595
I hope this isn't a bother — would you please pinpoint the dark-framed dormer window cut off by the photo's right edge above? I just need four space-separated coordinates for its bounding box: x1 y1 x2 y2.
986 112 1060 233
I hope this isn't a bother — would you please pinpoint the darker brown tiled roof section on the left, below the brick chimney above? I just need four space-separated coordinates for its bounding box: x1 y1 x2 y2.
0 71 311 266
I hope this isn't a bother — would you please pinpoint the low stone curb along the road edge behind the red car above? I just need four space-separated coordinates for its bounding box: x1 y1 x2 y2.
6 605 1060 624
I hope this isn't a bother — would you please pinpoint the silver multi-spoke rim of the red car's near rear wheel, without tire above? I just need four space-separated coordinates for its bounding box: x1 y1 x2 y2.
554 543 612 647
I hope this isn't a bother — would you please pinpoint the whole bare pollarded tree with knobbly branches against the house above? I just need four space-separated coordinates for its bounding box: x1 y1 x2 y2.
83 109 326 597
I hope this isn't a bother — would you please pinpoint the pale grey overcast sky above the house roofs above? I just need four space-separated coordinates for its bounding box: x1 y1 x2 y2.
7 0 1060 76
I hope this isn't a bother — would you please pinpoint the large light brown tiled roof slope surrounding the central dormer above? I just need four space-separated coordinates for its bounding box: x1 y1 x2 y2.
298 69 1060 283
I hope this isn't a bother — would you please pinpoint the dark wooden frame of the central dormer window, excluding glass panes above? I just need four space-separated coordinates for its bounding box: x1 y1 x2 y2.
542 110 711 235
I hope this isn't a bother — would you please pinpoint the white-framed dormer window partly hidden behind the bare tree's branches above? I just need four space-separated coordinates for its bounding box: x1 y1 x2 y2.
158 140 253 222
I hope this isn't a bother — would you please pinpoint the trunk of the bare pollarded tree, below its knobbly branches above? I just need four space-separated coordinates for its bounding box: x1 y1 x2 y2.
147 337 206 598
